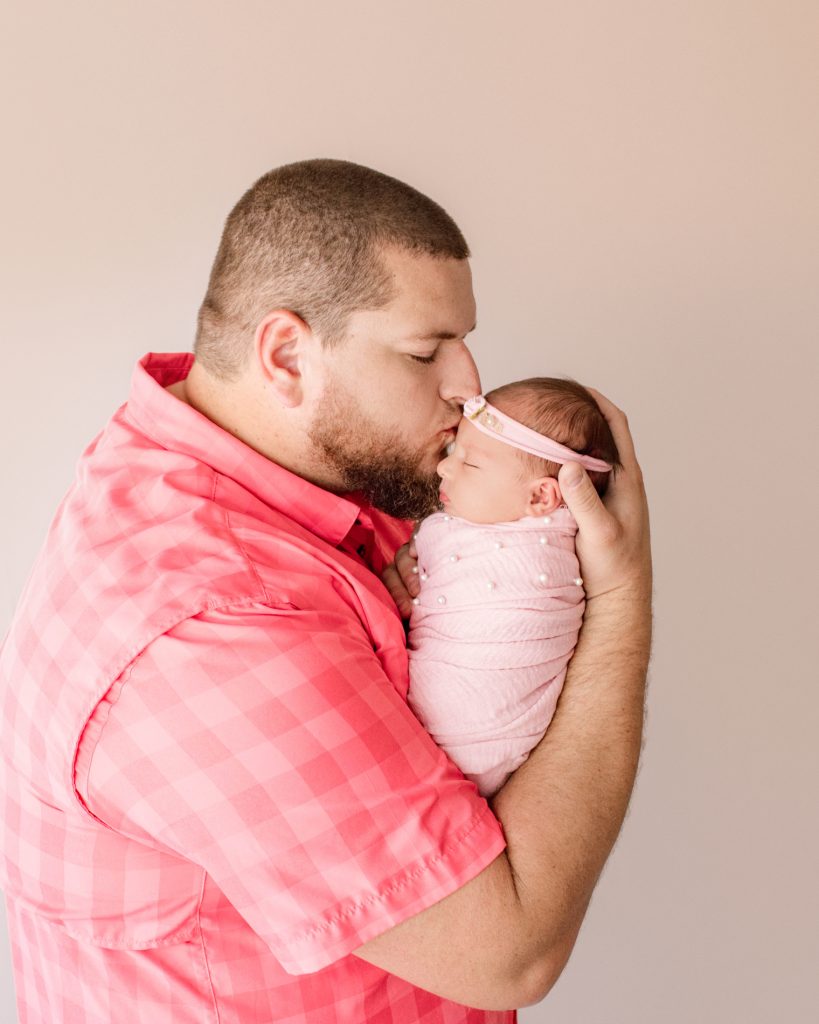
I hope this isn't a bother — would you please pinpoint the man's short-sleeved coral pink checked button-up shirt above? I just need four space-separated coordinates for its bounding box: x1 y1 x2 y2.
0 354 515 1024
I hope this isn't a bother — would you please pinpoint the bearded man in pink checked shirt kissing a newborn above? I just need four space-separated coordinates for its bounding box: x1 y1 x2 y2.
0 161 650 1024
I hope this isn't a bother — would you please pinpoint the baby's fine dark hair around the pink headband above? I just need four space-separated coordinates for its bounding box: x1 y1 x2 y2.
485 377 620 495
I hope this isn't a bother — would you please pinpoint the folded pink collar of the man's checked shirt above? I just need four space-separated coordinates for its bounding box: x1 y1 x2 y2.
126 352 361 547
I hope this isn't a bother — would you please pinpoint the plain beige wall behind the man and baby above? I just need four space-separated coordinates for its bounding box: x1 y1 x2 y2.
0 0 819 1024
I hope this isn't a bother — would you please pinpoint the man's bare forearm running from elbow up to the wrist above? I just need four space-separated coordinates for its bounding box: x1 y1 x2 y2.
492 587 651 987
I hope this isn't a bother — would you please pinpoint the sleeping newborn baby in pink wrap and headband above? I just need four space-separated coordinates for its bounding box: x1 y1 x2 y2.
407 377 618 797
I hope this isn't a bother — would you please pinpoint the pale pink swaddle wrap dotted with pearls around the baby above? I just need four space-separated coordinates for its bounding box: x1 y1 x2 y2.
407 507 585 796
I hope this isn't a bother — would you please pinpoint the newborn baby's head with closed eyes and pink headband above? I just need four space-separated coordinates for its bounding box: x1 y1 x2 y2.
438 377 619 522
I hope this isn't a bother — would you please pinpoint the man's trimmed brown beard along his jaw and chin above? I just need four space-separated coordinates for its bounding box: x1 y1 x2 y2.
308 385 443 519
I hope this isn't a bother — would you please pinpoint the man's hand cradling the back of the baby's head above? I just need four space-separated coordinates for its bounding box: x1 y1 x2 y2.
558 388 651 600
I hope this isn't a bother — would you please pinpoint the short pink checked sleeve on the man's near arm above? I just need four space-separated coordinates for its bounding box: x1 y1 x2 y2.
79 604 505 974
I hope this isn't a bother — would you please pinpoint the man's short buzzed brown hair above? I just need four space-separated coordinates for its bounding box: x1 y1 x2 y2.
195 160 470 380
